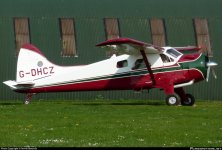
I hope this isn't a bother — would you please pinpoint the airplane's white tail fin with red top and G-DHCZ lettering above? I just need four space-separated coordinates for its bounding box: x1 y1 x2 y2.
16 44 56 83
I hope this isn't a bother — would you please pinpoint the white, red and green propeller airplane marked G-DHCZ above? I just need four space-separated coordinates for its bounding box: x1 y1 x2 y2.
3 37 218 106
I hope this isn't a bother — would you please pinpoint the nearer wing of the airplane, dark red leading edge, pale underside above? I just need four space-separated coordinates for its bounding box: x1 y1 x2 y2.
96 38 162 55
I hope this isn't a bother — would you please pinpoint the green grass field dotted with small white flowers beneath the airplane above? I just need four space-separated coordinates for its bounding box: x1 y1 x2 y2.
0 100 222 147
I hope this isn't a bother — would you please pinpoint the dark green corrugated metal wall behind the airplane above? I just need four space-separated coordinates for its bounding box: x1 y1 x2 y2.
0 0 222 100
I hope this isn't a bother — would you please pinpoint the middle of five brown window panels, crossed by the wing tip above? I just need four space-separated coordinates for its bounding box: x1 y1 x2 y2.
104 18 120 57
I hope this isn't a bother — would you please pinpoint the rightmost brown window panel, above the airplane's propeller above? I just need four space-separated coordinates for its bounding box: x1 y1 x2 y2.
193 18 212 56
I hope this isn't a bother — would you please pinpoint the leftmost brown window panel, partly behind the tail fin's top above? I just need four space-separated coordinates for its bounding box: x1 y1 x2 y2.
14 18 30 56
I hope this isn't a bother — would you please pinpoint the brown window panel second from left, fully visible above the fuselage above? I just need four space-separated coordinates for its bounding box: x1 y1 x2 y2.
60 18 77 57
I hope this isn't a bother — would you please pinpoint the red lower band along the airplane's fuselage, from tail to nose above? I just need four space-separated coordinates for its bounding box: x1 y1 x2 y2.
16 69 204 93
